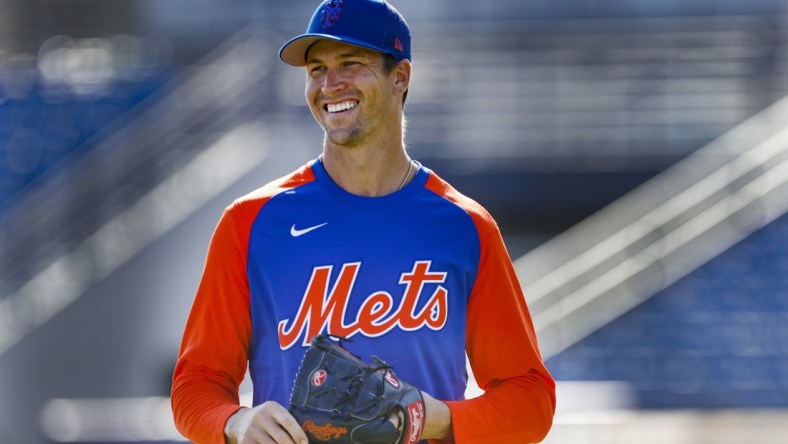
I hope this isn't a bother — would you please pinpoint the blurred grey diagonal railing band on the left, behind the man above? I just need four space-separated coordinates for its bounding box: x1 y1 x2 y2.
0 29 284 354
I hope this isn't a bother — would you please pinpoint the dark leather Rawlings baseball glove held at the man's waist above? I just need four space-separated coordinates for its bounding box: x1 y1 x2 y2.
290 335 424 444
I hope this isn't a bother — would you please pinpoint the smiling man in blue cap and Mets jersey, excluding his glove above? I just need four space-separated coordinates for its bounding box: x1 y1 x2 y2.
172 0 555 444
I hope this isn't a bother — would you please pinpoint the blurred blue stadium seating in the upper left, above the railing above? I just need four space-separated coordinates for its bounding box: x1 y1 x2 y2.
0 36 169 212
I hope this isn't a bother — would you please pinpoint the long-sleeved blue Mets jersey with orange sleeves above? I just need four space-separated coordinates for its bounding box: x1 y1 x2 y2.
172 160 555 443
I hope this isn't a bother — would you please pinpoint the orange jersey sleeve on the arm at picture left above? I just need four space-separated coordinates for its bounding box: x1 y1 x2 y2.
172 202 262 444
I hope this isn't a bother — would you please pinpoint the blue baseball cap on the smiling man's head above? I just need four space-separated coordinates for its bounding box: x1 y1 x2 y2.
279 0 410 66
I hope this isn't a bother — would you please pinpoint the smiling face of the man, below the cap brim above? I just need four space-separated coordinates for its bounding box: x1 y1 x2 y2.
305 40 401 146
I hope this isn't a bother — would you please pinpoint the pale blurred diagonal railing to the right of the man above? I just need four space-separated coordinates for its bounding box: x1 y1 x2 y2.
515 93 788 357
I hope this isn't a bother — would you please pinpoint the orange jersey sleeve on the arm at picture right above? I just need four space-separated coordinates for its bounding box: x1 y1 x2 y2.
433 176 556 444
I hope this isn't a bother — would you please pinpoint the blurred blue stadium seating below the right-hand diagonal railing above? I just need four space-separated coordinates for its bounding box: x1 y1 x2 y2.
548 215 788 409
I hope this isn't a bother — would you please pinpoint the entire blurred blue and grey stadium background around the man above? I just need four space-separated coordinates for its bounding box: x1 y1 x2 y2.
0 0 788 444
